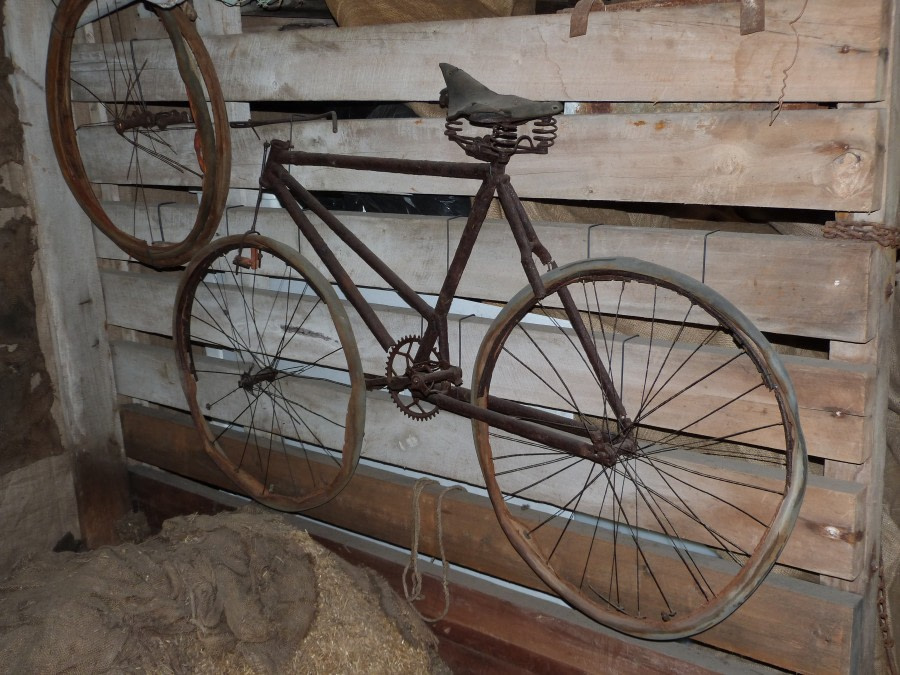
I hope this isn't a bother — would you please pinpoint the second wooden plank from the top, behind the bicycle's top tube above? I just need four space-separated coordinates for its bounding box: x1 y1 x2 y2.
79 109 883 212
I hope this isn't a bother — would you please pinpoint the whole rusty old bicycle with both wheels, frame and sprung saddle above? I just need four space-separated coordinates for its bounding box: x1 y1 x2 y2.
173 64 806 639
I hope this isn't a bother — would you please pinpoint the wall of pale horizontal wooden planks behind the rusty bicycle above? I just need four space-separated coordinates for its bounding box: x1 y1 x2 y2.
42 0 896 672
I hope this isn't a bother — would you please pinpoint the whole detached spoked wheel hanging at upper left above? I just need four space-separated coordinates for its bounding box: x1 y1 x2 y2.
47 0 231 267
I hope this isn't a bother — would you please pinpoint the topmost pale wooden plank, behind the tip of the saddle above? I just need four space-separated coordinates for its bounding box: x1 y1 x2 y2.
73 0 886 103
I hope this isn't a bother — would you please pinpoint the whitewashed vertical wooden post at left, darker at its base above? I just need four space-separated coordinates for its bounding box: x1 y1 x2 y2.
3 2 130 547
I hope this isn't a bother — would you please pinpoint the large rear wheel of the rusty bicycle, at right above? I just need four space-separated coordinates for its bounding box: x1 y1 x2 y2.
472 259 807 639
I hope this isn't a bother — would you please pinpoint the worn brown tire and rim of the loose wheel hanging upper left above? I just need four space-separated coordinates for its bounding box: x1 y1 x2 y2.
46 0 231 268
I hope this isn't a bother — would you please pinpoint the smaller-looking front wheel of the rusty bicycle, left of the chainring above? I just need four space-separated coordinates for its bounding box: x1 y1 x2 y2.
173 234 365 511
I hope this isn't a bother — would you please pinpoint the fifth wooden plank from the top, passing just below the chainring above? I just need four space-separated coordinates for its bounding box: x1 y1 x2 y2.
114 342 866 579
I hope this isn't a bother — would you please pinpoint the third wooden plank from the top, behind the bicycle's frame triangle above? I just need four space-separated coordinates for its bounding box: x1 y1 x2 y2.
95 202 883 342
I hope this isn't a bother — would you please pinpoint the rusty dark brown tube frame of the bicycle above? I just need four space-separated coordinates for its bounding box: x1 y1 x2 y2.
260 141 630 464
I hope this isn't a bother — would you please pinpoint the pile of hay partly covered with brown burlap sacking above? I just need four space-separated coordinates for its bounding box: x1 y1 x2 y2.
0 510 449 673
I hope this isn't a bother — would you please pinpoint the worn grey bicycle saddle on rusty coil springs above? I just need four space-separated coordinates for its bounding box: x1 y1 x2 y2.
440 63 563 127
